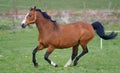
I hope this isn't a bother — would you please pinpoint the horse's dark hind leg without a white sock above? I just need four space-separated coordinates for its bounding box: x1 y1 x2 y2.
74 44 88 66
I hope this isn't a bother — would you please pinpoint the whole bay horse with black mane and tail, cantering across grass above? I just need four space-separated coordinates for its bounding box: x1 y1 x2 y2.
21 7 117 67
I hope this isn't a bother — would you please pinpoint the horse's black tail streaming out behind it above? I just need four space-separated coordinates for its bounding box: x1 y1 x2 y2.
92 22 117 40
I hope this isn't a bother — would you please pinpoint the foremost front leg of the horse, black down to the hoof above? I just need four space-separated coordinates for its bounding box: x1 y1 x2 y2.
32 44 44 67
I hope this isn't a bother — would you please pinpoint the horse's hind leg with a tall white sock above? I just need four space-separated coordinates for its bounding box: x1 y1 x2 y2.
64 45 78 67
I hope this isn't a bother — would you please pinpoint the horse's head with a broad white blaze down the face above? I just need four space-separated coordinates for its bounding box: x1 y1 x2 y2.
21 6 36 28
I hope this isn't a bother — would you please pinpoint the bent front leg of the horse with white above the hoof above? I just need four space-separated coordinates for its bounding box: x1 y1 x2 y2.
44 45 58 67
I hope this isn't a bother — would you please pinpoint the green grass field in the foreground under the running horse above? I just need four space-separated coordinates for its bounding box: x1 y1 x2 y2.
0 28 120 73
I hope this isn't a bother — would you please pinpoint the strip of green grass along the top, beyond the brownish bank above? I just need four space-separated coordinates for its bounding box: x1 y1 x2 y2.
0 0 120 12
